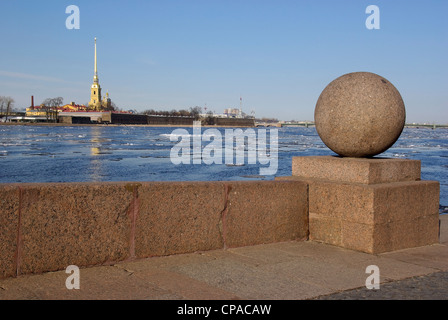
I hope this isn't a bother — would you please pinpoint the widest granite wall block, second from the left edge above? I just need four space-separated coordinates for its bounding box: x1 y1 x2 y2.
17 183 133 274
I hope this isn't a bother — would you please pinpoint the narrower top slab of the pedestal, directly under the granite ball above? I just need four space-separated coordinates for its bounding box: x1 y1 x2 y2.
292 156 421 184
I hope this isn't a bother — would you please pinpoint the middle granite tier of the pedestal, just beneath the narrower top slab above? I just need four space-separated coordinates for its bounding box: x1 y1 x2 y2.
308 180 440 224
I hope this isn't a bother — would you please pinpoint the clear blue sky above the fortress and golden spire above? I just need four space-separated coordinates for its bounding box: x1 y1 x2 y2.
0 0 448 123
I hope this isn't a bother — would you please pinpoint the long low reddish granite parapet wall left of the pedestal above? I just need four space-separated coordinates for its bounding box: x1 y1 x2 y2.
0 181 308 278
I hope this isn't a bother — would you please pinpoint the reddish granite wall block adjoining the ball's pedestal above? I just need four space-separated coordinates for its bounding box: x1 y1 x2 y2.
223 181 308 247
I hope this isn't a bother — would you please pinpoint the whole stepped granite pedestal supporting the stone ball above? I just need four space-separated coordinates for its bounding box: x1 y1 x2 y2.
284 156 439 254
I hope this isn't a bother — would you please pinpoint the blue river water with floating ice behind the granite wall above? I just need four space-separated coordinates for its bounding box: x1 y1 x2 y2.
0 125 448 206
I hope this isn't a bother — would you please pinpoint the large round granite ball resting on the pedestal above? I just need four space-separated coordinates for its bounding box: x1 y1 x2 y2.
314 72 406 157
